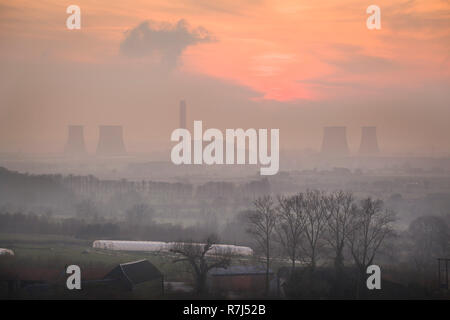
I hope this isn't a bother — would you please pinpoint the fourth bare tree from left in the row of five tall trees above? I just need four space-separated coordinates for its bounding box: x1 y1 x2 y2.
326 190 356 273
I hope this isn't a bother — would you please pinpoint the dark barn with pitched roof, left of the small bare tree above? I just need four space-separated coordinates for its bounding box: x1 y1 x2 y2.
103 260 164 290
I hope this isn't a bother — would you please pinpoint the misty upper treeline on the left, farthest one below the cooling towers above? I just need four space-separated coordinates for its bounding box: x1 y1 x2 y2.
0 167 270 207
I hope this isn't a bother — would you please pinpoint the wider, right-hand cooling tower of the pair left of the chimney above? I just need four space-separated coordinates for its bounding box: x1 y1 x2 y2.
97 126 126 156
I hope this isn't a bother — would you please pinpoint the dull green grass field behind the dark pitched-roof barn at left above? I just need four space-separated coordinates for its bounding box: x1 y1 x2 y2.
0 233 190 298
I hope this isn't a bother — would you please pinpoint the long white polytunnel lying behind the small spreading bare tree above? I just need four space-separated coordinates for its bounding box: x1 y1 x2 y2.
92 240 253 256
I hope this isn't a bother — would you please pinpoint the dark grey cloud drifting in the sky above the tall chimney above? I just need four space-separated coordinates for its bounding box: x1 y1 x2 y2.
120 19 215 68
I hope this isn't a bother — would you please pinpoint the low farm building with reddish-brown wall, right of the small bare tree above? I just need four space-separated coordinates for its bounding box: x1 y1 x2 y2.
208 266 274 295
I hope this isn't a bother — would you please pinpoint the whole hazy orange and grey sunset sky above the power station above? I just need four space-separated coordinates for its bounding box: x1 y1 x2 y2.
0 0 450 153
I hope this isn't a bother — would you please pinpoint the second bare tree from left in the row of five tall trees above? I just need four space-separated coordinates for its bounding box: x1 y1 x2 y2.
276 193 306 270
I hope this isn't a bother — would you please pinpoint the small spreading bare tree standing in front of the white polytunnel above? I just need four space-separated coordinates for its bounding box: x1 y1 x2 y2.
170 236 231 294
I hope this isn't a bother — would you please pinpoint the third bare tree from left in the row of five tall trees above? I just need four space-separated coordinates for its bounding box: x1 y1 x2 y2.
302 190 328 270
